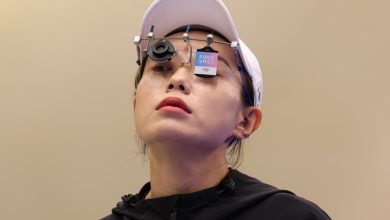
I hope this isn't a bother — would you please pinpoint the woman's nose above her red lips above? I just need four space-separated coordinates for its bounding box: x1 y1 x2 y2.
167 67 193 95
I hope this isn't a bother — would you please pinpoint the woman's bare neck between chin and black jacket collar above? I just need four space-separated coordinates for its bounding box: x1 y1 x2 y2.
149 146 228 198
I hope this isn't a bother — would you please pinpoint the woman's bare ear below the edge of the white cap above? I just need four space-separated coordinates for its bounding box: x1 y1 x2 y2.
234 106 263 139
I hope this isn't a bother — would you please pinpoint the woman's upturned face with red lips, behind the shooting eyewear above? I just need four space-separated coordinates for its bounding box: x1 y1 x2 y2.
134 31 243 151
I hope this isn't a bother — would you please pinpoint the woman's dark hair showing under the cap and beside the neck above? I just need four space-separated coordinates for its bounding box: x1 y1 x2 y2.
134 27 254 167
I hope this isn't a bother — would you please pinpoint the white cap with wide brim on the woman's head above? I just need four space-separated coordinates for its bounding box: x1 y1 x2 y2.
140 0 263 106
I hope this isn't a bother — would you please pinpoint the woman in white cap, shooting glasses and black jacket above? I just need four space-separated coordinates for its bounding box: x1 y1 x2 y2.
103 0 329 220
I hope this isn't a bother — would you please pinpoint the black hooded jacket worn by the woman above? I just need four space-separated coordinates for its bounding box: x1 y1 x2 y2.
102 169 330 220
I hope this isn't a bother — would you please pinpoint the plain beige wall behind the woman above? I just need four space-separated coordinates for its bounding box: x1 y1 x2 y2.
0 0 390 220
